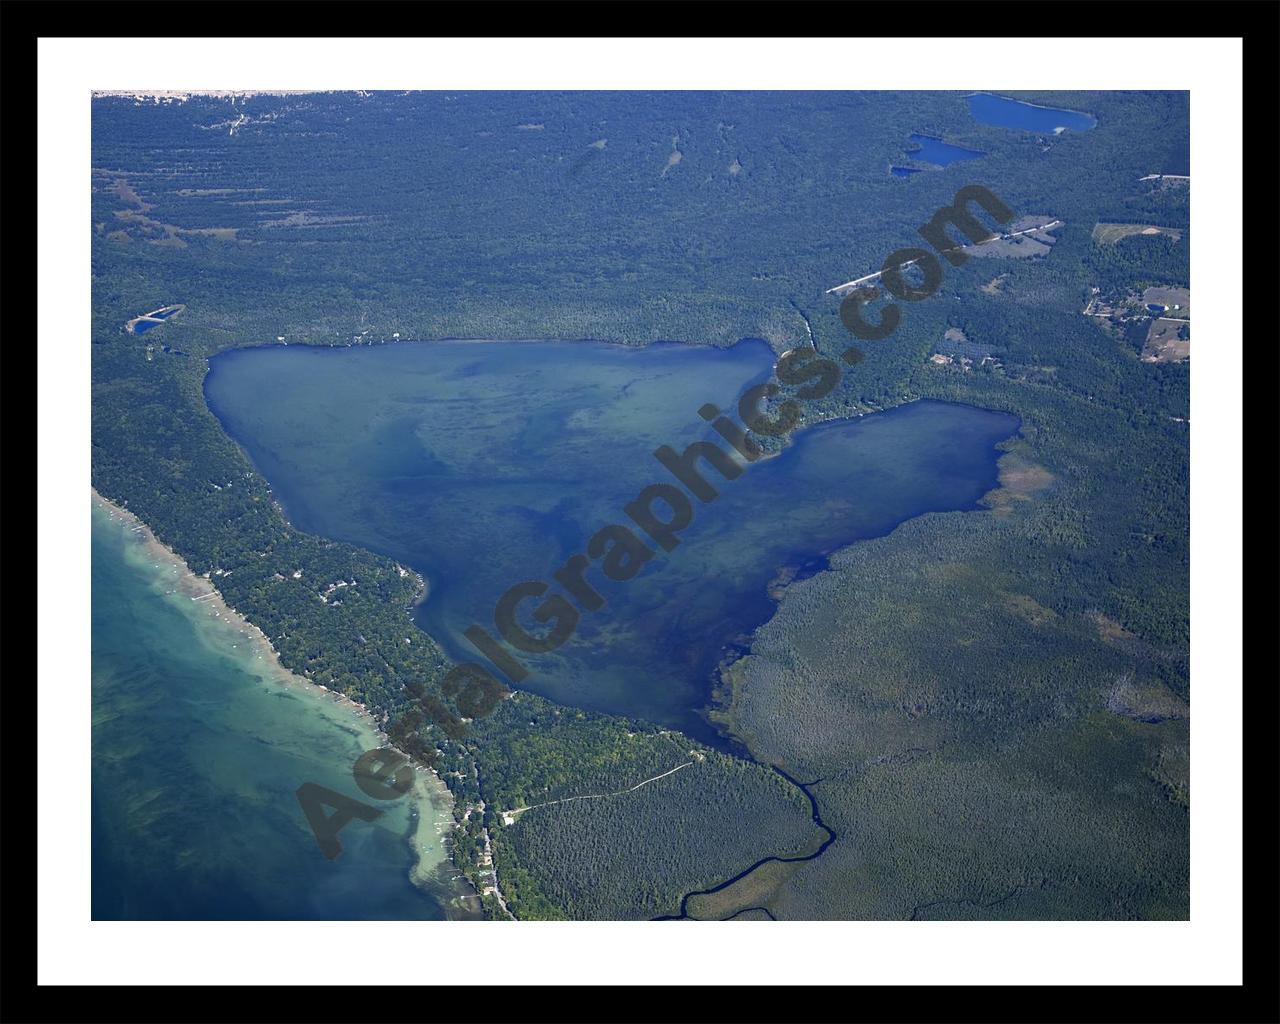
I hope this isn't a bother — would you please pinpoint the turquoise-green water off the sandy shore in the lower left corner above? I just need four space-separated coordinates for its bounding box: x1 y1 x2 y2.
91 506 448 920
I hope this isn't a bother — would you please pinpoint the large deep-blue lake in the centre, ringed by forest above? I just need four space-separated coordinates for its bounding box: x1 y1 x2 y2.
205 340 1018 742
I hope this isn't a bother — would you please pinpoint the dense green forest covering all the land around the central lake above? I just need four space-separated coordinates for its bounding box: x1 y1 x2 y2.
91 92 1190 918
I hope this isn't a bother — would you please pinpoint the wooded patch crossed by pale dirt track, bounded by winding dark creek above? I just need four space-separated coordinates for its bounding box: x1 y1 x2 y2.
481 710 820 920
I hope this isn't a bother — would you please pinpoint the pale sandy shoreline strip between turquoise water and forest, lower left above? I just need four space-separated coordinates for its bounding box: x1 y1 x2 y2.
90 488 463 916
